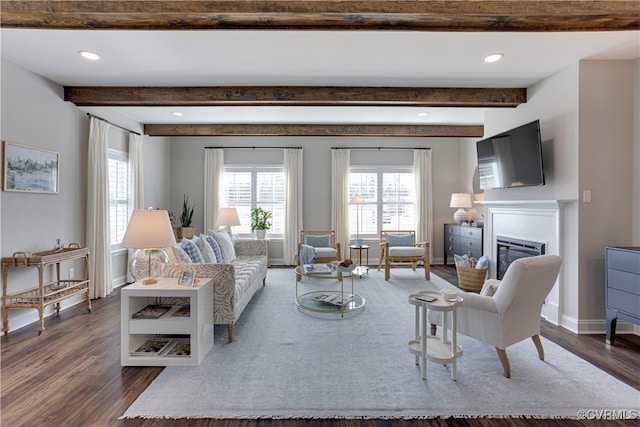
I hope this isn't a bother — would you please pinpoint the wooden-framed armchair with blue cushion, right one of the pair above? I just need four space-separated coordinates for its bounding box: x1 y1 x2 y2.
378 230 431 280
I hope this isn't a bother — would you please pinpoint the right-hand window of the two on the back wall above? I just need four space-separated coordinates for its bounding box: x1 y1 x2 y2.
349 166 415 238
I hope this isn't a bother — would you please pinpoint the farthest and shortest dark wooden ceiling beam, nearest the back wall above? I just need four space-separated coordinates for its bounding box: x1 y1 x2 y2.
144 124 484 138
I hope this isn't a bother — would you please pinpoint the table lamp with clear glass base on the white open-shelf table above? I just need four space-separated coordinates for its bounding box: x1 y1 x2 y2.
121 208 176 285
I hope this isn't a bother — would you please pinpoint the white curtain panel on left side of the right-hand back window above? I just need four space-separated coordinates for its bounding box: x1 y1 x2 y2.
331 148 351 259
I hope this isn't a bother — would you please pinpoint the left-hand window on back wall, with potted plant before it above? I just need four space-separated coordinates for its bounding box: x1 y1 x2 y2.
222 166 285 238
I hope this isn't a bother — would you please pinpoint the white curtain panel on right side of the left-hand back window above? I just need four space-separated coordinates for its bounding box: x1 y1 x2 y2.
282 148 303 265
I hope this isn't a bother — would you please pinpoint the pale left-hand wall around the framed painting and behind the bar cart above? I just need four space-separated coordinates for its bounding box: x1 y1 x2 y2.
0 59 170 330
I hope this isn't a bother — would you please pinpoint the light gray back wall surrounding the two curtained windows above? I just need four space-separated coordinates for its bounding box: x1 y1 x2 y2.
171 137 461 263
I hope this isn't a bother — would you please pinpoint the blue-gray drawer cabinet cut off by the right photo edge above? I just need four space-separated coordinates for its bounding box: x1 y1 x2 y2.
605 247 640 344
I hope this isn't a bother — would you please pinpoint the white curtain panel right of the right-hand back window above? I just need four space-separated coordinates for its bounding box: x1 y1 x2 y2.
413 149 433 260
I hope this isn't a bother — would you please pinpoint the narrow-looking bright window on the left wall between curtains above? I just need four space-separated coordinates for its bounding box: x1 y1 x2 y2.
108 149 129 246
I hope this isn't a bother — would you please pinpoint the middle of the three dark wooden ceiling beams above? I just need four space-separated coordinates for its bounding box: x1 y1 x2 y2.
64 86 527 108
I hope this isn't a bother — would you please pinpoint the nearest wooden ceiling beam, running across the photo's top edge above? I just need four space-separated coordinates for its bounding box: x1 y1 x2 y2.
0 0 640 32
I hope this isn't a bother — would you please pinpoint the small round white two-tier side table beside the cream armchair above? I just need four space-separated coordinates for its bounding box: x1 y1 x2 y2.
409 291 463 381
